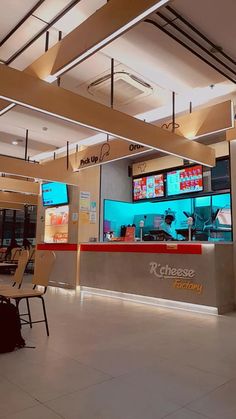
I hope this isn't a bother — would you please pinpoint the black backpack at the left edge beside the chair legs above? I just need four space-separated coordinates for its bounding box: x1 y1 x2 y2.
0 296 25 353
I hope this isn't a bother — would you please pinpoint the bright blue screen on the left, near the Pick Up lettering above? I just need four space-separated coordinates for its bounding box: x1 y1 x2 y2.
42 182 68 207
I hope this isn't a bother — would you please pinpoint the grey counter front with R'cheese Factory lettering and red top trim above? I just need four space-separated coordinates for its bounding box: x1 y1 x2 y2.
79 242 234 314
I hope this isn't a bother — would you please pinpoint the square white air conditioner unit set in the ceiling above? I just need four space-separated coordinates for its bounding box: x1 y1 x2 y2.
87 71 153 106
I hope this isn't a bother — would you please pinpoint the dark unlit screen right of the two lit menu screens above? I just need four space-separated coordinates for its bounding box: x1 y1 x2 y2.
211 158 230 191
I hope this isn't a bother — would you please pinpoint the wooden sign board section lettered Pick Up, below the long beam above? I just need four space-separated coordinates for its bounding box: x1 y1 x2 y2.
71 140 150 171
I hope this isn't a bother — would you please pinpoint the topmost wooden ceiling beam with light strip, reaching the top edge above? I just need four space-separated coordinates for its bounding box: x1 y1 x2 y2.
0 0 170 115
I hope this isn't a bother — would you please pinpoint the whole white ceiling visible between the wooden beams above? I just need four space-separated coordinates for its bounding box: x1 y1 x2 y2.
0 0 236 159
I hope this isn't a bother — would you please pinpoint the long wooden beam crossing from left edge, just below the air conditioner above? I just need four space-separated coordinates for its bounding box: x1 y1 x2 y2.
0 65 215 166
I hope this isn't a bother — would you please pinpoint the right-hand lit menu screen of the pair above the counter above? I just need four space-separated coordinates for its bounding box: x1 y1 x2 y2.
166 165 203 196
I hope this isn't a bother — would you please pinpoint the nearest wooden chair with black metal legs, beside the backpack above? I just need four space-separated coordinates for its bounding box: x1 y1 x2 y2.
1 251 56 336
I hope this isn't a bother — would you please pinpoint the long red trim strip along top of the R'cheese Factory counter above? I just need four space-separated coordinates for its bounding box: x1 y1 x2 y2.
80 243 202 255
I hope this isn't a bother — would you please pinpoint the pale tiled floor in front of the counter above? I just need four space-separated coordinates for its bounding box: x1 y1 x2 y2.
0 278 236 419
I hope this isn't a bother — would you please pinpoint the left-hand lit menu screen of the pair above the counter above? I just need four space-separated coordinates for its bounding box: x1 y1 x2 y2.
133 174 164 201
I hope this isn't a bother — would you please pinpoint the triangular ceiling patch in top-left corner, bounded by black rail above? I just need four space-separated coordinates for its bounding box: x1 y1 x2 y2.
0 0 38 40
